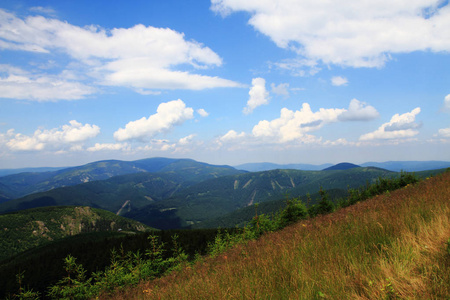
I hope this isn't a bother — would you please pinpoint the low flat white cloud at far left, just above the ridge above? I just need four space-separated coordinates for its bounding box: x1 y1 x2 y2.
6 120 100 151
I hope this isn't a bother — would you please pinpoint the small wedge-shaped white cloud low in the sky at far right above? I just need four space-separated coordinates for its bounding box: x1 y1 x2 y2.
359 107 420 141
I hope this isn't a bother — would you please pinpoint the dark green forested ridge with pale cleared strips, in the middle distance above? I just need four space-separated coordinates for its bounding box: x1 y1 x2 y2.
124 168 398 229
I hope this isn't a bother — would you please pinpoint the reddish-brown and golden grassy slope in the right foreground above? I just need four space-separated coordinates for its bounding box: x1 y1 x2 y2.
115 172 450 299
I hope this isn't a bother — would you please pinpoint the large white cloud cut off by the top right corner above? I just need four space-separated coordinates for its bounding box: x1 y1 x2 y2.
211 0 450 67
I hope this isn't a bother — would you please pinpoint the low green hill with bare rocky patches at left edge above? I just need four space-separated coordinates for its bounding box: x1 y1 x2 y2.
0 206 150 261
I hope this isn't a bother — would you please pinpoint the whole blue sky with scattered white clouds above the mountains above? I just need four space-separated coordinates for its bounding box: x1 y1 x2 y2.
0 0 450 169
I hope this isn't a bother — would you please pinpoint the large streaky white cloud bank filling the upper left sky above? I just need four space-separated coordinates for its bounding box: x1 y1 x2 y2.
0 8 241 100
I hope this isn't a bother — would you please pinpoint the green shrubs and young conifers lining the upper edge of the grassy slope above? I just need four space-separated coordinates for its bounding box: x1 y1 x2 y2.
7 170 432 299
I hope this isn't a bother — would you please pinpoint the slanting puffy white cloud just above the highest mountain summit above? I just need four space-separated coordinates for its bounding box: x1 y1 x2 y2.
114 99 194 142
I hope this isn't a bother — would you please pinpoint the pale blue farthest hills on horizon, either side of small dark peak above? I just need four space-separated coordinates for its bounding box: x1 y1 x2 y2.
234 161 450 172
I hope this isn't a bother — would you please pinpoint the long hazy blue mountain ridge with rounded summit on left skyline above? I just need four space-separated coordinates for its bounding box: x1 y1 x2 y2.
0 157 242 199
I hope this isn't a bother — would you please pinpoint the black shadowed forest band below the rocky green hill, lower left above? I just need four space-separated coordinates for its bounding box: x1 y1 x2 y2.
0 229 225 299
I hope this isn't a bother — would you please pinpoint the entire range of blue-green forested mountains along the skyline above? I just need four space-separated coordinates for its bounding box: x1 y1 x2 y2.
0 157 445 229
